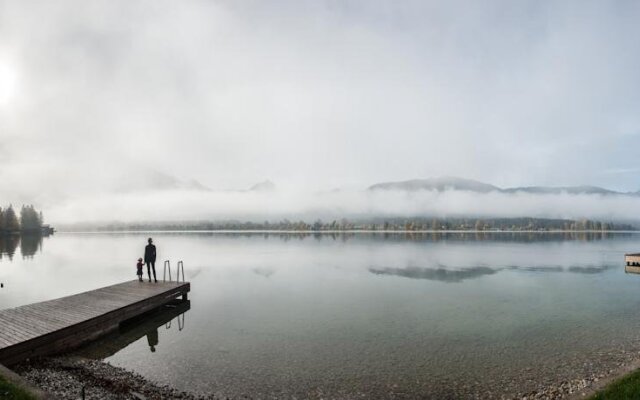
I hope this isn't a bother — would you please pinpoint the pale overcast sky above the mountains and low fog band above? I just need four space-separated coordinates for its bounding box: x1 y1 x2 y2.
0 0 640 222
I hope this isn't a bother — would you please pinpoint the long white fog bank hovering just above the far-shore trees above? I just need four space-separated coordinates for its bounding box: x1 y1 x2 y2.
45 189 640 223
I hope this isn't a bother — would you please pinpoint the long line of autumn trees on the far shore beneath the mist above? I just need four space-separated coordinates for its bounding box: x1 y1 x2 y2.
87 217 637 232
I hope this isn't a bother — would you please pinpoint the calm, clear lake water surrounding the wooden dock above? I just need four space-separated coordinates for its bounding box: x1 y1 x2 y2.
0 233 640 398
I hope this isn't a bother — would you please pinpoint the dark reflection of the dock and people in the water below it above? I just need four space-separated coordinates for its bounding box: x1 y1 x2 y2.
74 300 191 360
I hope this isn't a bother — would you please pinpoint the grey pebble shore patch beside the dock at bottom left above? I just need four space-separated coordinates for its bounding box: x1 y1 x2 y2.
13 357 217 400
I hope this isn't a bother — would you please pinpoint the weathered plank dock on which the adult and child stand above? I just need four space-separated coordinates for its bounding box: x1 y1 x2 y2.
0 280 191 365
